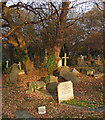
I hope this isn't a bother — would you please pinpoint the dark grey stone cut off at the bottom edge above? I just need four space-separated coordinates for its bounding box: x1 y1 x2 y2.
15 110 35 119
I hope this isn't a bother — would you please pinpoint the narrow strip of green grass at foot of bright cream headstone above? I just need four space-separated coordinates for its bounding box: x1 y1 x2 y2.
61 99 103 108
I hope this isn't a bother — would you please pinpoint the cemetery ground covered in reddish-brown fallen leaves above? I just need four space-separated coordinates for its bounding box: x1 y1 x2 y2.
2 68 105 119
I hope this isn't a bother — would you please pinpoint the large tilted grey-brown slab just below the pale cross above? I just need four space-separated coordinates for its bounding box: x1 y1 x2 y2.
59 66 80 83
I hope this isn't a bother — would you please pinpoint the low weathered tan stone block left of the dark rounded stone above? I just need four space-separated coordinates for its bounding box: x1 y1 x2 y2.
29 81 46 92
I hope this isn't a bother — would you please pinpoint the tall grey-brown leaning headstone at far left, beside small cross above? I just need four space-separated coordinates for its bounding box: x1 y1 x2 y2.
6 63 19 84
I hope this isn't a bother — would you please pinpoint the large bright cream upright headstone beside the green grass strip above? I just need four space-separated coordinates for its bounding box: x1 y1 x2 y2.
57 81 74 103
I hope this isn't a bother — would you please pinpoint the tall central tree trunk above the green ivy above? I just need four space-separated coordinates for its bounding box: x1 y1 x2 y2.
54 2 71 61
